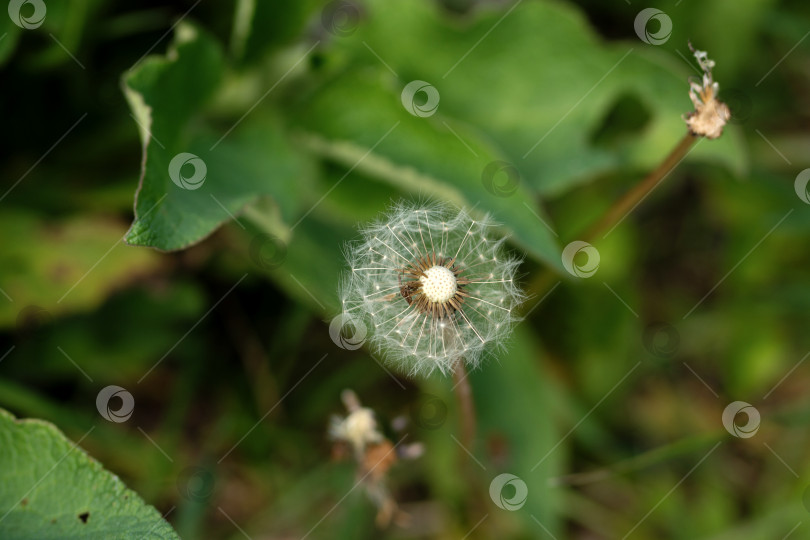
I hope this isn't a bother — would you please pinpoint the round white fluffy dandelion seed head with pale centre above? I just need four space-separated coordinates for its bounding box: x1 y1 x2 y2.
341 203 523 374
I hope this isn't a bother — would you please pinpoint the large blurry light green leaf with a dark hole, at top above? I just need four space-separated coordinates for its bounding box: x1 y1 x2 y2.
324 0 746 195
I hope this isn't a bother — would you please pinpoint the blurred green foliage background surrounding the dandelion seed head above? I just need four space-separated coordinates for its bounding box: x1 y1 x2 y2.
0 0 810 539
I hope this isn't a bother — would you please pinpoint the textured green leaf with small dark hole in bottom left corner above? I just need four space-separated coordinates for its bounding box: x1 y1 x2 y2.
0 409 179 540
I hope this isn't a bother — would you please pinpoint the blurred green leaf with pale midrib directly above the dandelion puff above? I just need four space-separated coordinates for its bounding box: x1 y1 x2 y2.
296 69 560 267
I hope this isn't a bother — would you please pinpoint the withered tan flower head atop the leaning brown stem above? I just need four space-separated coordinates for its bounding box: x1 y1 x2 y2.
684 43 731 139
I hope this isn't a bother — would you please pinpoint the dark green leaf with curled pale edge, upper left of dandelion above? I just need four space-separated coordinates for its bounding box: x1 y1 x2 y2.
124 24 305 250
